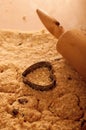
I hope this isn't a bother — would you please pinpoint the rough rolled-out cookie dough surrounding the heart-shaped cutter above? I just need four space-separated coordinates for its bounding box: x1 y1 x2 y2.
0 31 86 130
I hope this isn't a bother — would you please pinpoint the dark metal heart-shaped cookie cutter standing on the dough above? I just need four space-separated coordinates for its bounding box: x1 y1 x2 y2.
22 61 56 91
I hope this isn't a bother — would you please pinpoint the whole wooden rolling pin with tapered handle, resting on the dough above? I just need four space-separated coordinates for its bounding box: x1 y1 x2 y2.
37 9 86 80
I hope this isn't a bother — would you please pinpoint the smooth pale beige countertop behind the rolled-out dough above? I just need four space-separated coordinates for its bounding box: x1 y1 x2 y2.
0 0 86 31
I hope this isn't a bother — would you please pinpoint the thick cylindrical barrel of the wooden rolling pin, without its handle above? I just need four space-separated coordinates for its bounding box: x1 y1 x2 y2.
57 30 86 80
